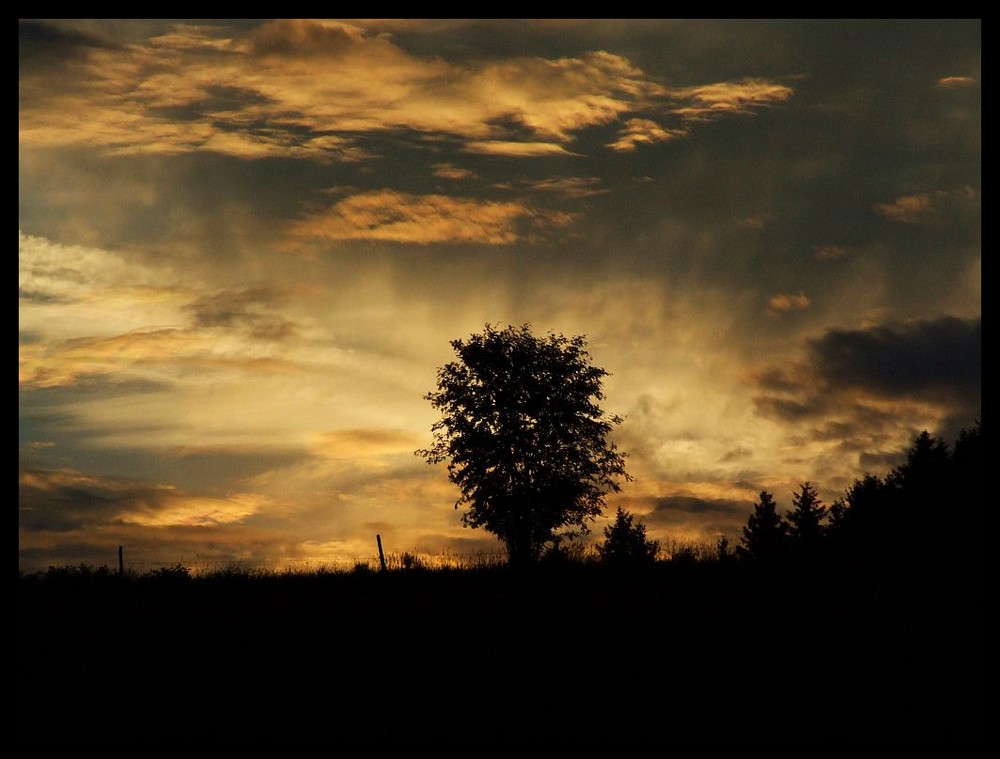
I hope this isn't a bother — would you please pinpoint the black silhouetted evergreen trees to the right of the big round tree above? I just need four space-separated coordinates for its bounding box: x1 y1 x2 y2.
597 421 982 569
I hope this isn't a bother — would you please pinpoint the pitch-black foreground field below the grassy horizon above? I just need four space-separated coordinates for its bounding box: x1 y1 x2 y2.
17 563 981 752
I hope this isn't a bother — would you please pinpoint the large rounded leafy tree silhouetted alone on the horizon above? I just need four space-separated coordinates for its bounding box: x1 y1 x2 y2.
416 324 630 564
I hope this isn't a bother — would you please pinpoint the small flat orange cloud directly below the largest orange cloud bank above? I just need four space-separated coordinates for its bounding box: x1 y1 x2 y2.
291 190 572 245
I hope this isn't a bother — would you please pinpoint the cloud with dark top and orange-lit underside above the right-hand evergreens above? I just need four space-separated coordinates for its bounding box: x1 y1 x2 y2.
752 316 982 470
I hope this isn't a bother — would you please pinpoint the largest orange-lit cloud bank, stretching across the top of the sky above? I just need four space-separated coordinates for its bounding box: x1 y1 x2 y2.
18 19 792 162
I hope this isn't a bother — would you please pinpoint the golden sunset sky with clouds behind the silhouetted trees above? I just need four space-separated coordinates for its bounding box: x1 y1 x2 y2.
18 19 982 572
